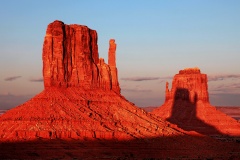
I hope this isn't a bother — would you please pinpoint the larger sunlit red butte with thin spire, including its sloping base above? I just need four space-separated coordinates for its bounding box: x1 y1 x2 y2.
0 21 182 141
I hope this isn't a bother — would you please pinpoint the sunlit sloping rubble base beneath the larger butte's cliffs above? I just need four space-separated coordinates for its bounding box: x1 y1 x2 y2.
0 87 182 141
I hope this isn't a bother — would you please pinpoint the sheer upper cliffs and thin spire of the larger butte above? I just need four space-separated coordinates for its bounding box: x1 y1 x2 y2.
42 21 120 93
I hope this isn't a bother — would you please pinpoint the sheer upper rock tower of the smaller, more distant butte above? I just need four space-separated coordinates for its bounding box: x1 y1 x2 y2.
165 68 209 103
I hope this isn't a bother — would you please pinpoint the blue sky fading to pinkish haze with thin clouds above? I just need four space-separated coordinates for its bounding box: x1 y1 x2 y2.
0 0 240 110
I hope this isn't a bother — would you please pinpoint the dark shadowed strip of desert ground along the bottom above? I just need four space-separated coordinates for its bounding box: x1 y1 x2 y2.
0 135 240 159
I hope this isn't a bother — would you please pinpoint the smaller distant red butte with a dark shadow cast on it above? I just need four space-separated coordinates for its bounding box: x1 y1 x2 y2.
152 68 240 136
